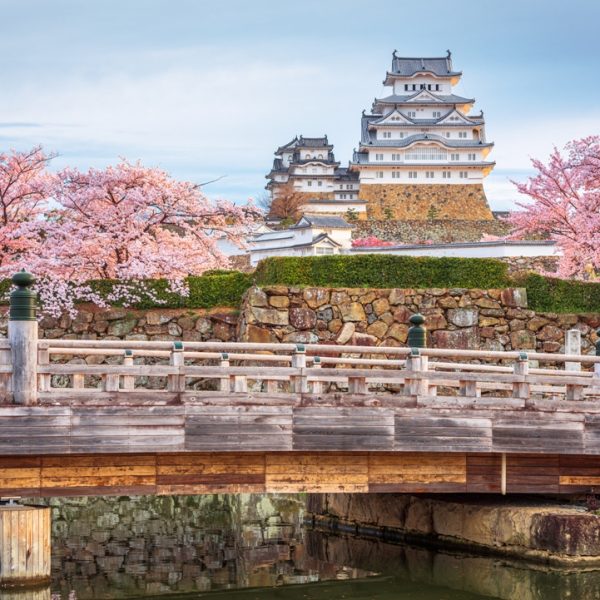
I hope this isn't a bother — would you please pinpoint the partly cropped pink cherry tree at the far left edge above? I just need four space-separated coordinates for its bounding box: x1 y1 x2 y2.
0 146 54 276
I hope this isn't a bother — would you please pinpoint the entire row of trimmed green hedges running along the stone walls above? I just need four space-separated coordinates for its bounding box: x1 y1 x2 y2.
0 254 600 313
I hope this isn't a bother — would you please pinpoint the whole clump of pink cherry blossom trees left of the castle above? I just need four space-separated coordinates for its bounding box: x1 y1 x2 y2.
0 154 260 315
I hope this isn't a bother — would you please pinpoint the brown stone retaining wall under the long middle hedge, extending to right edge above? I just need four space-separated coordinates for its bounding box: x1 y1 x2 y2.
240 286 600 353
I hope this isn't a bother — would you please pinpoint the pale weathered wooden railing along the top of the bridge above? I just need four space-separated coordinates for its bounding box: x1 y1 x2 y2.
0 340 600 406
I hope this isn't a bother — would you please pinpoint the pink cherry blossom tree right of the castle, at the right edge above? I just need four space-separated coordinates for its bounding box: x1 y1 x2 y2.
509 136 600 279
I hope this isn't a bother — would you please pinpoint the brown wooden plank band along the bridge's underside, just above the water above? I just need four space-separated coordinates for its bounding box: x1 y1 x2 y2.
0 452 600 497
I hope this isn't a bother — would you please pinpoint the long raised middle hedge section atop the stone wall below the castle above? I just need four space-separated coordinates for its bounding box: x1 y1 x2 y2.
255 254 510 289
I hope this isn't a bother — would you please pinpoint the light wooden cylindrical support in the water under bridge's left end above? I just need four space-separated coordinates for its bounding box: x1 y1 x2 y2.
0 502 51 584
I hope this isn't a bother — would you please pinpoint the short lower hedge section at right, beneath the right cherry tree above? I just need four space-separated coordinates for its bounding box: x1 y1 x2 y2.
518 273 600 313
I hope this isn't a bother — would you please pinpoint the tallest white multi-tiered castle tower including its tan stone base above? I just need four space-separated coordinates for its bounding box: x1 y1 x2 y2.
350 51 495 220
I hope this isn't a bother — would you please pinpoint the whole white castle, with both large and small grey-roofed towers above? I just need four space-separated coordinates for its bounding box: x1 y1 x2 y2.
266 51 495 220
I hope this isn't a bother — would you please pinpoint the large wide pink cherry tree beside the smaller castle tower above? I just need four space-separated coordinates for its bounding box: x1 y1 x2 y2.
38 161 259 282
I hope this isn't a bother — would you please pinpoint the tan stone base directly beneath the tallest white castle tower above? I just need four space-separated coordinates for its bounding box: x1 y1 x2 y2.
359 184 494 221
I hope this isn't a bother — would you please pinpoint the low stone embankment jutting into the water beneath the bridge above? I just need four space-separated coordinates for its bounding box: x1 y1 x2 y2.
308 494 600 568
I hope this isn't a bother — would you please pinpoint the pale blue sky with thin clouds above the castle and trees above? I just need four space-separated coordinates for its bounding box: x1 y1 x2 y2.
0 0 600 210
